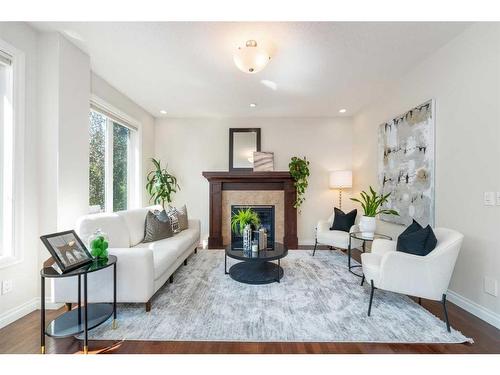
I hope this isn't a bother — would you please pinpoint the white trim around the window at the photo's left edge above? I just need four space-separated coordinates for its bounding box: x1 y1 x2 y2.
0 39 26 268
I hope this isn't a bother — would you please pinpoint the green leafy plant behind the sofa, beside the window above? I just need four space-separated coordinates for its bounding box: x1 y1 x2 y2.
146 158 180 208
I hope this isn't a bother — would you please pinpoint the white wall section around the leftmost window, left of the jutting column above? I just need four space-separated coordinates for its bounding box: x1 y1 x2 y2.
0 22 39 327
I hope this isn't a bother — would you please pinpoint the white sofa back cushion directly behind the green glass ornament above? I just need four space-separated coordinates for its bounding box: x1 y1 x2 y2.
76 213 130 248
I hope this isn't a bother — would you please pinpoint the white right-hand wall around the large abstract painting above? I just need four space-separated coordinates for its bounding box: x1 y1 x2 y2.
353 23 500 324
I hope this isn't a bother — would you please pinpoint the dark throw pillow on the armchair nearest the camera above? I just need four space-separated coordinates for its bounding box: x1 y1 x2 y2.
396 220 437 256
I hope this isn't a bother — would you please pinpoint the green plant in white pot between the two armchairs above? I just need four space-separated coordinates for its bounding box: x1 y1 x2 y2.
351 186 399 238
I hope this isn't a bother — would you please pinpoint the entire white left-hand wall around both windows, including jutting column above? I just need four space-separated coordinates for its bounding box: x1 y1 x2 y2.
0 22 154 328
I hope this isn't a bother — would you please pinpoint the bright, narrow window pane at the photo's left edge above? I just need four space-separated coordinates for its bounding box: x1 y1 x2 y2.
0 50 14 257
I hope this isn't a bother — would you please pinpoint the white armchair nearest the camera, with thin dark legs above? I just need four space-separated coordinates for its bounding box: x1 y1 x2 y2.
361 228 464 331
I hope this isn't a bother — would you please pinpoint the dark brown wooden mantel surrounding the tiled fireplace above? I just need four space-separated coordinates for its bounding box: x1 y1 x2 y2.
202 171 298 249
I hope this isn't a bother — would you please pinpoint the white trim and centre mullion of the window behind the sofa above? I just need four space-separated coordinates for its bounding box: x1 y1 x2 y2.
90 94 142 212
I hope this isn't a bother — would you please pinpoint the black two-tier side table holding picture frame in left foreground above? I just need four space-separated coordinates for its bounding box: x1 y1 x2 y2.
40 255 117 354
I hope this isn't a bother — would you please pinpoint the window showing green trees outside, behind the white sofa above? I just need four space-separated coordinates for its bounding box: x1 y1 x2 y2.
89 109 135 212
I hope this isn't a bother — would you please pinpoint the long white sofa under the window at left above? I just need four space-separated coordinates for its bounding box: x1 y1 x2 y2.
52 207 200 311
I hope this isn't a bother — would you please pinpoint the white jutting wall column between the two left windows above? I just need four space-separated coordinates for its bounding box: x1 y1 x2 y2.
38 33 90 262
